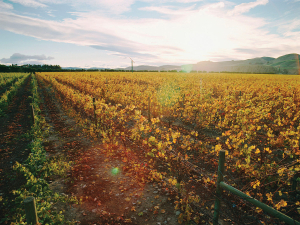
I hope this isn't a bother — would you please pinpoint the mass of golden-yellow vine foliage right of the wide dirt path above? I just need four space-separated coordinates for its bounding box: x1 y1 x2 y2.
37 72 300 219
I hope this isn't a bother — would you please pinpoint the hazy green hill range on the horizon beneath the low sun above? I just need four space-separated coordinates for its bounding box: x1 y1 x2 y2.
117 53 300 74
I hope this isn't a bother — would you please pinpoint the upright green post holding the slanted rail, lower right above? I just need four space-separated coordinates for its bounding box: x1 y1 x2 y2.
213 150 225 225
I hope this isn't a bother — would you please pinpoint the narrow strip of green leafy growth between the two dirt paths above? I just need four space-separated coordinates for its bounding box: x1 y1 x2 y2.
0 76 78 224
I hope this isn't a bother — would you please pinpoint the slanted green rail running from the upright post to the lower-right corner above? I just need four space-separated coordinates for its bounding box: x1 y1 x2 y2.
219 181 300 225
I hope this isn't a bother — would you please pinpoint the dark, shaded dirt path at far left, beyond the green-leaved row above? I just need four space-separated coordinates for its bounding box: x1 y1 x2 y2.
0 76 32 221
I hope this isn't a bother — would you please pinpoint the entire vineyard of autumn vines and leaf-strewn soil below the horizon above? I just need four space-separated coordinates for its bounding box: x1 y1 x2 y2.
0 72 300 224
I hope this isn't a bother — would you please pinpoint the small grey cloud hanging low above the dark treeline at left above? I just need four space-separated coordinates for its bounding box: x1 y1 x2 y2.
0 53 54 64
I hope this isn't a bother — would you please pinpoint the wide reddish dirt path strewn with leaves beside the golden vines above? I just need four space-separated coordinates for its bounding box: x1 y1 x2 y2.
38 76 180 225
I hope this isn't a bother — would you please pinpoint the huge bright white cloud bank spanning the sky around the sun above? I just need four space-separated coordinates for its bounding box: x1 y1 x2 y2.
0 0 300 64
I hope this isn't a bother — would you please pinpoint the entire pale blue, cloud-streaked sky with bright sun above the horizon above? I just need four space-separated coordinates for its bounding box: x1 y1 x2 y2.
0 0 300 68
